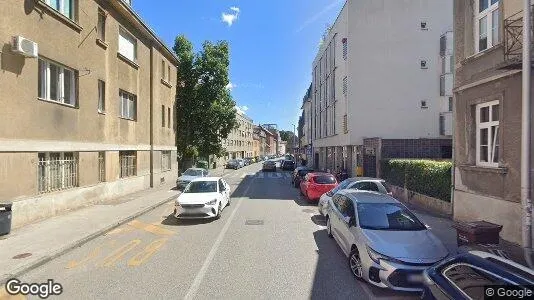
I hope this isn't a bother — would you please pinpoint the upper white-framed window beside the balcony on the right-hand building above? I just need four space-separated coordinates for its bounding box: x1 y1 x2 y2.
475 0 500 52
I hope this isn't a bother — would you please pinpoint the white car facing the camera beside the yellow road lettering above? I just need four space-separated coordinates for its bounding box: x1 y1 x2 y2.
174 177 230 219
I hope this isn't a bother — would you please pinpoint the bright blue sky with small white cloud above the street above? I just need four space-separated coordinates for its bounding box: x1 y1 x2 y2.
133 0 344 130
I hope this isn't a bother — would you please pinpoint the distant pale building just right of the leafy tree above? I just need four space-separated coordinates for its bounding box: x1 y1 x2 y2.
223 111 254 160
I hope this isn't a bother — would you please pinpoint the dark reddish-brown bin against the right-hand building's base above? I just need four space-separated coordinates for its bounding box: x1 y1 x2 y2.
452 221 502 246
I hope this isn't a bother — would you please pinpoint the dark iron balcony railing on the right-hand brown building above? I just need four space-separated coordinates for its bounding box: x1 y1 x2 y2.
504 6 534 64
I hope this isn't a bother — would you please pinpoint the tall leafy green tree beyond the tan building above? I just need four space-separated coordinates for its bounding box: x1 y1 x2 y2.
173 35 237 169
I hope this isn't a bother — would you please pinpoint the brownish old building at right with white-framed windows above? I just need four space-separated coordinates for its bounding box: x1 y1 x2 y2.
454 0 534 244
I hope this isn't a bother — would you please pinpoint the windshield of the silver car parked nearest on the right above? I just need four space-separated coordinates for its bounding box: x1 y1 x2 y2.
358 203 426 231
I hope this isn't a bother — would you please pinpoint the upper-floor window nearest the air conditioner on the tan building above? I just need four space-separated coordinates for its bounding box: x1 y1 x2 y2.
38 58 77 106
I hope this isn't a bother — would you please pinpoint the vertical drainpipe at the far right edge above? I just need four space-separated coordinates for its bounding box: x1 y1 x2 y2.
521 0 533 268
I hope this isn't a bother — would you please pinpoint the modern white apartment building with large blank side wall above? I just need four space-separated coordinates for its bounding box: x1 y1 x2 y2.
310 0 453 176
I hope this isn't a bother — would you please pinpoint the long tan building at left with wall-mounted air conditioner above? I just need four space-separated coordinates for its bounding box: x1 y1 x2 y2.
0 0 177 227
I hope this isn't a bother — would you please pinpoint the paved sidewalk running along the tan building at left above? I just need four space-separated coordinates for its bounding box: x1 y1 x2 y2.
0 183 179 285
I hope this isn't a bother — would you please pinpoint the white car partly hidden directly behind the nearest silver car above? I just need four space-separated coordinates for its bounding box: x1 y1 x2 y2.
317 177 391 216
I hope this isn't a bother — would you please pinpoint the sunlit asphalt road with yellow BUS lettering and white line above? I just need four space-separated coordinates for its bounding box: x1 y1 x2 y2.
15 163 418 300
